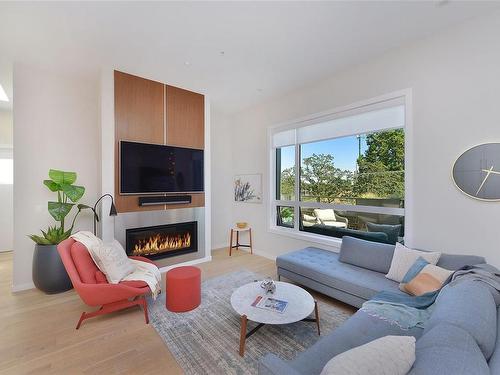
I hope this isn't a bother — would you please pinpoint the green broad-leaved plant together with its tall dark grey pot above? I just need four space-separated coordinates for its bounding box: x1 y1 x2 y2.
29 169 90 294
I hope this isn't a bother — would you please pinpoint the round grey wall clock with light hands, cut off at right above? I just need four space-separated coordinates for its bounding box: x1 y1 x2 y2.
452 143 500 201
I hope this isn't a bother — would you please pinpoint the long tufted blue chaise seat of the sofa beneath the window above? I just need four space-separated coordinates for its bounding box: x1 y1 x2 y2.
276 247 403 300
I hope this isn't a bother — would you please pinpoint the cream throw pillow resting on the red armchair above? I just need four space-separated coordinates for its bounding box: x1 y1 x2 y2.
92 240 135 284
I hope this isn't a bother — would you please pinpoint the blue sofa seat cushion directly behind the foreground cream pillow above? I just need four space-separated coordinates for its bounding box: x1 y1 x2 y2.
290 310 423 375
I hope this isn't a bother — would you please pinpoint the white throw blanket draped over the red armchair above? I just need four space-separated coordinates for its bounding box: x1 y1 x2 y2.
71 231 161 299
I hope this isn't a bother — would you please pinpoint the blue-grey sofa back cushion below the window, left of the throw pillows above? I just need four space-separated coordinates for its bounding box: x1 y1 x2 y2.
339 236 394 273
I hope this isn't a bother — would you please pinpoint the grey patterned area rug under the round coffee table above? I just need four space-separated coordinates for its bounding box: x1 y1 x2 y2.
148 270 351 375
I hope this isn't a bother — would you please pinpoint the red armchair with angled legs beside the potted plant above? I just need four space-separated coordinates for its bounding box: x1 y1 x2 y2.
57 238 154 329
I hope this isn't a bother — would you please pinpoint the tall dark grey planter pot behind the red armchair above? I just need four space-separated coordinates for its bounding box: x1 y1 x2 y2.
33 245 73 294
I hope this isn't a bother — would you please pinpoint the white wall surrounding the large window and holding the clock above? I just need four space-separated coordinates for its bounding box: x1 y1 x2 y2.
212 14 500 266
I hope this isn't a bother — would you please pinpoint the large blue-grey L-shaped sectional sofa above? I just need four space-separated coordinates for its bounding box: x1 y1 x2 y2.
259 237 500 375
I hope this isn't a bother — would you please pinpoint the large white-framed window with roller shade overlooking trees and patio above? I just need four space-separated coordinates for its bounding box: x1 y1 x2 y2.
271 97 405 243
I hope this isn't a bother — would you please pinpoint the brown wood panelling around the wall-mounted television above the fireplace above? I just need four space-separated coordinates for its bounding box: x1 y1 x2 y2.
114 71 205 212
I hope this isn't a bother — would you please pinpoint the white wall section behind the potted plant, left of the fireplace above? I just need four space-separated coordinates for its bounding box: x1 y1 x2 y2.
13 64 100 290
